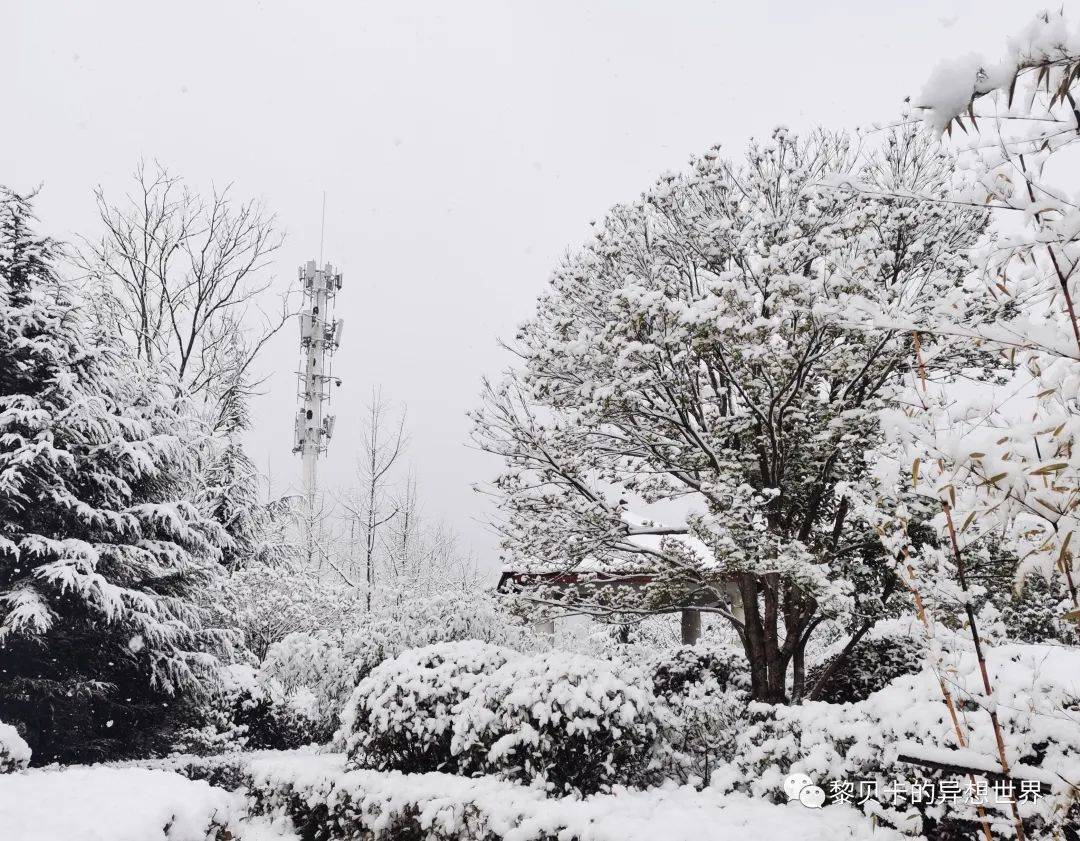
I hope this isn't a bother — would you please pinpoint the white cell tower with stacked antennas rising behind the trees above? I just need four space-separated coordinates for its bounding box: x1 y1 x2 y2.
293 260 343 515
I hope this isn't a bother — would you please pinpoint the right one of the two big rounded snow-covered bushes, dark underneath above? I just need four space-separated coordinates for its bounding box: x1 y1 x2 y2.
453 651 662 795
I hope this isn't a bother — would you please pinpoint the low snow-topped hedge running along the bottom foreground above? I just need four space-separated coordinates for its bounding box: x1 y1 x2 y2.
247 755 904 841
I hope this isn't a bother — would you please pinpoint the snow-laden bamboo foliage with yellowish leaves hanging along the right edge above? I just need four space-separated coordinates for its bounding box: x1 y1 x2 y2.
887 12 1080 618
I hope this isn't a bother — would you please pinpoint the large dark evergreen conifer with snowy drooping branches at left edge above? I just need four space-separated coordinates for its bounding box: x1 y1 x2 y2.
0 190 234 762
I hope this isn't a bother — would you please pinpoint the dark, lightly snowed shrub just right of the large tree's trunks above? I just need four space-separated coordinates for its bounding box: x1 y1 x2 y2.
806 633 926 704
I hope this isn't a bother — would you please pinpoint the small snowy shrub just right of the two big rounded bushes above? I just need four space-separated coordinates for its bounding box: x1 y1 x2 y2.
651 642 751 784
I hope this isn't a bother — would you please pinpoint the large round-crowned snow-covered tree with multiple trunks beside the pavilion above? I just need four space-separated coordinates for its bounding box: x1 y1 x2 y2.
475 130 983 701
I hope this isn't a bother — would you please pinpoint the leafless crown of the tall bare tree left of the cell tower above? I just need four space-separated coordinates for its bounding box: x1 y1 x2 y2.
77 162 291 422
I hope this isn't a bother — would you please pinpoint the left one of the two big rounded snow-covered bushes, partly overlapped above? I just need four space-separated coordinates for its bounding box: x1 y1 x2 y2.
341 640 516 773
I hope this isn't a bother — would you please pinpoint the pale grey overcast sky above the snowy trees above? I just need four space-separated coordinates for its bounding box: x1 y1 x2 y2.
6 0 1045 566
